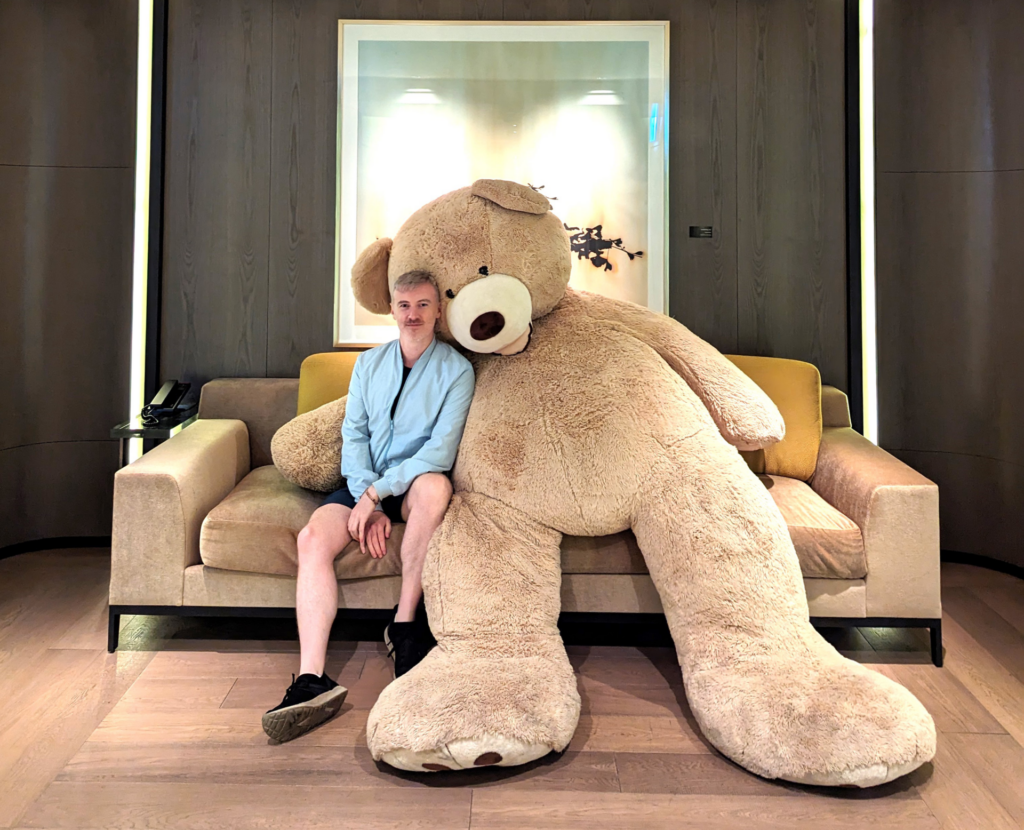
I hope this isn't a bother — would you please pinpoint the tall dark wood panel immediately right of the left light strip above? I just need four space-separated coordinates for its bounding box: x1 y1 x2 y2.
160 0 271 388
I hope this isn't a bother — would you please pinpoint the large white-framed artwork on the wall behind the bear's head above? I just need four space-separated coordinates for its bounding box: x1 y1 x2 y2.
335 20 669 347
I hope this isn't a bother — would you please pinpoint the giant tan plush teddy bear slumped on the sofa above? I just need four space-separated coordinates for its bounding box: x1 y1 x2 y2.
274 179 935 786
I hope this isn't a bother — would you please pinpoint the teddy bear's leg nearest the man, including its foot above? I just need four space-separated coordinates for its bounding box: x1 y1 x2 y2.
367 493 580 772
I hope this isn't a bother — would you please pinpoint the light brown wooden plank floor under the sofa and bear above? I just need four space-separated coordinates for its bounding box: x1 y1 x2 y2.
0 550 1024 830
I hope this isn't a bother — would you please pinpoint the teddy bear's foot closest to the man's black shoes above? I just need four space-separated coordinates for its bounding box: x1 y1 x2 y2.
367 648 580 773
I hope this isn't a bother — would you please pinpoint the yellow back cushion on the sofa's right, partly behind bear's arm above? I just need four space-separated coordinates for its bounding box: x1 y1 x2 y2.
726 354 821 481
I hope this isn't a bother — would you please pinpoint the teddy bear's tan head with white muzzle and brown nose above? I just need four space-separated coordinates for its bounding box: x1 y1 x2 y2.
352 179 572 354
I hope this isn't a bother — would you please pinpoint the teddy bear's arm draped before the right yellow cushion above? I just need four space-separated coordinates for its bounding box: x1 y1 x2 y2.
570 290 785 450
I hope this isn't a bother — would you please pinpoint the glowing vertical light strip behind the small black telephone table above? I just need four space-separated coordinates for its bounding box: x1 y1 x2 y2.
128 0 154 464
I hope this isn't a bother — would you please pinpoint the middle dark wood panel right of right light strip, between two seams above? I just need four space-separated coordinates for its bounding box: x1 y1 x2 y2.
878 172 1024 464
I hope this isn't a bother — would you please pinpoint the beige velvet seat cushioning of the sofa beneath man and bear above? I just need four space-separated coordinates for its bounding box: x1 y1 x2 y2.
200 465 867 579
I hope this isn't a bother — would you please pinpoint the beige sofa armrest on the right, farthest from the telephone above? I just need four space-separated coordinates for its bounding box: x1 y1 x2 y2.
810 427 942 618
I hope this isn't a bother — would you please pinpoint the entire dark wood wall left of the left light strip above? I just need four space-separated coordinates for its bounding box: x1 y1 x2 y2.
0 0 138 548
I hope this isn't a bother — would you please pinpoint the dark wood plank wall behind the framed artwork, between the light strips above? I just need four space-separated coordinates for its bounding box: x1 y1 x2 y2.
160 0 847 388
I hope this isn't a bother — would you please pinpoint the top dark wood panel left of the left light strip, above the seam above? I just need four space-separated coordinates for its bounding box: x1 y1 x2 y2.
0 0 138 167
